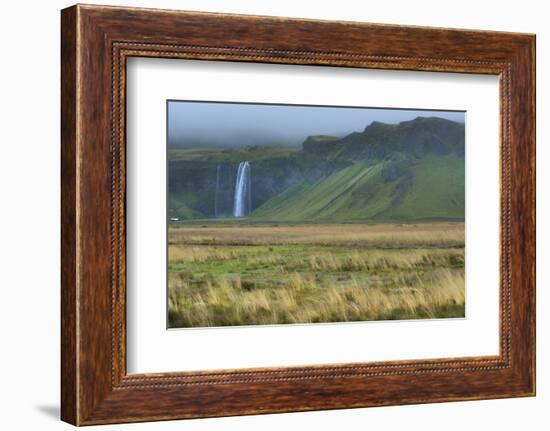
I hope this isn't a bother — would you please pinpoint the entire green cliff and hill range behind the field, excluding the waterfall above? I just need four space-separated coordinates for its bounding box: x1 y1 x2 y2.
168 116 465 222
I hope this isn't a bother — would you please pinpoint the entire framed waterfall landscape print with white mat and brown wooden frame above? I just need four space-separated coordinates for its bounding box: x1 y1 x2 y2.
61 5 535 425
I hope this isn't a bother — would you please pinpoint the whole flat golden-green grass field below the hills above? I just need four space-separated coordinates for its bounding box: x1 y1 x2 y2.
168 223 465 328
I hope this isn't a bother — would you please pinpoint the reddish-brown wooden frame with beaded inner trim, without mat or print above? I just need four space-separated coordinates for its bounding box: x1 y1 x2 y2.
61 5 535 425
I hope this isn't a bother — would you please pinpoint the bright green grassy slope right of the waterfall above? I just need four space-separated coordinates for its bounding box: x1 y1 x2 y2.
252 155 464 221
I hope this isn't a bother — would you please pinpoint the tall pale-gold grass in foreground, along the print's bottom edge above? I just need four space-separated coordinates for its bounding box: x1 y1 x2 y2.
169 270 464 327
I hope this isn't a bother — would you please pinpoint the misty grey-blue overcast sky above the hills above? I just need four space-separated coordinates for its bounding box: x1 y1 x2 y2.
168 101 464 147
